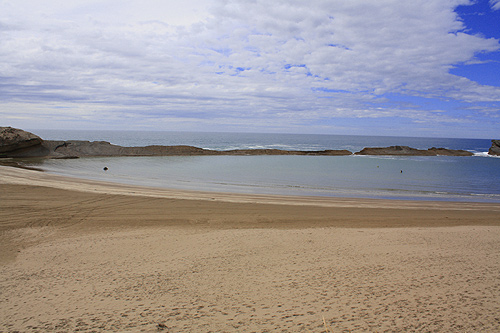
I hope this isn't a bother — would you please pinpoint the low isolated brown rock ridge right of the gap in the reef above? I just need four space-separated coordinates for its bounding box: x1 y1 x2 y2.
356 146 474 156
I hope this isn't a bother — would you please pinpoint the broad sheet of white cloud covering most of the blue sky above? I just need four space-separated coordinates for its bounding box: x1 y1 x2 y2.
0 0 500 135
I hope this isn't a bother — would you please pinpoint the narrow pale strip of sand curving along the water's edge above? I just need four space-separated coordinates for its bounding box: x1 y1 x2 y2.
0 165 500 211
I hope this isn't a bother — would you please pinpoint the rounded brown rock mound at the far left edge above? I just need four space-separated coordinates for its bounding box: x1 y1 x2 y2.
0 127 43 156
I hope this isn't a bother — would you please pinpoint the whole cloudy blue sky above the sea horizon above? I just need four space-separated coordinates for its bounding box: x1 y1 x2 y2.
0 0 500 139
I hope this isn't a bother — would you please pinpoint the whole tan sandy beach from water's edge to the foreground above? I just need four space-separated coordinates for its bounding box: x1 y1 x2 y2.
0 167 500 332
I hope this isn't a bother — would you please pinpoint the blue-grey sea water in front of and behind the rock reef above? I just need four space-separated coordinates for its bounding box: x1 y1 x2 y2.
26 130 500 203
